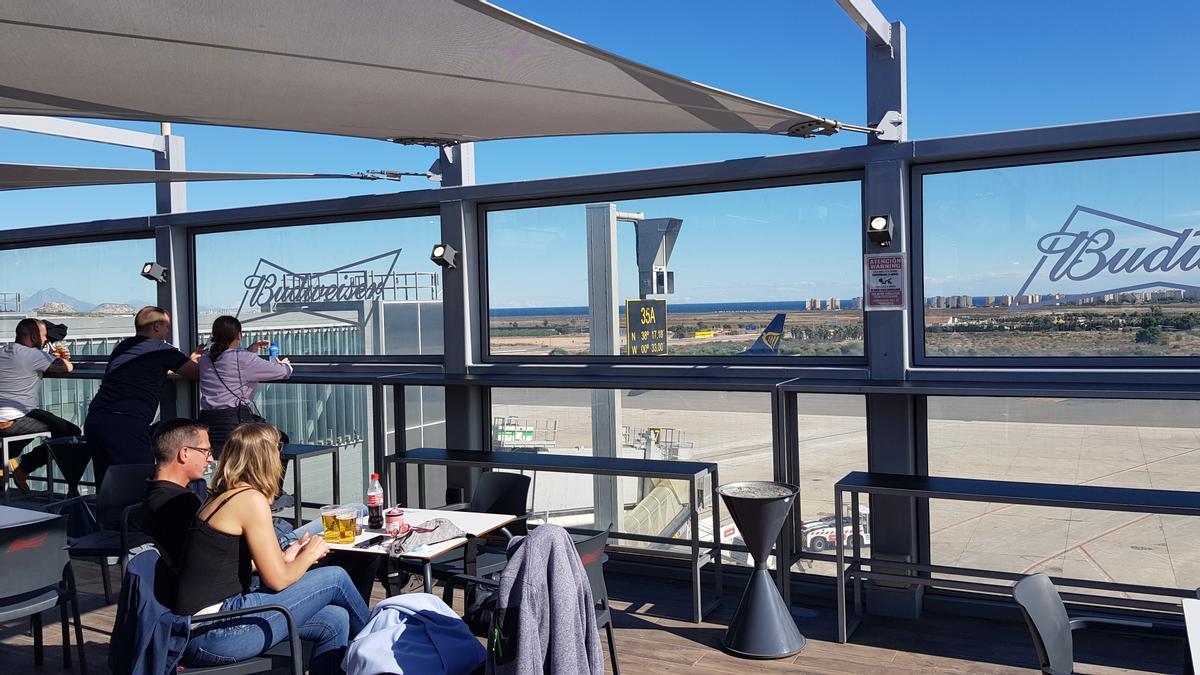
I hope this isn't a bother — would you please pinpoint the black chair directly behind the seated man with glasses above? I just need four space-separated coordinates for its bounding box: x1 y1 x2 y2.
60 464 155 604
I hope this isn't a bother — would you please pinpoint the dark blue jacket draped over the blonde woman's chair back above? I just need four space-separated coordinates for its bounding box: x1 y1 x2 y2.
108 548 191 675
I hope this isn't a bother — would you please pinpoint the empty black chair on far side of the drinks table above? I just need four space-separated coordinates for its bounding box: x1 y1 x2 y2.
396 471 529 595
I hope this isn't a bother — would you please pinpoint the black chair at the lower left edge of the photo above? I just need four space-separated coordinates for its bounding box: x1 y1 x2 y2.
0 518 88 673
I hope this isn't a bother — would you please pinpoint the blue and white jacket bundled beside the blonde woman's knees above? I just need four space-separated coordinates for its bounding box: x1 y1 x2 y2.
342 593 487 675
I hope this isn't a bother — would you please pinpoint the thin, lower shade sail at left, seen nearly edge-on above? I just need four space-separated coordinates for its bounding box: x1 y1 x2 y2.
0 163 368 190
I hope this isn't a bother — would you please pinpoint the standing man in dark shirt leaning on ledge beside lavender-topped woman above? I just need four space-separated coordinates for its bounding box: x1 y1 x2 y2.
84 307 204 485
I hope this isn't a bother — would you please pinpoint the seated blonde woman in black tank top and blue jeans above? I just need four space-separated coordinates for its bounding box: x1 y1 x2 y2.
175 423 368 674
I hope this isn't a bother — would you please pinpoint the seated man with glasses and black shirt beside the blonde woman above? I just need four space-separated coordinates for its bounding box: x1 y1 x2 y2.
143 419 212 572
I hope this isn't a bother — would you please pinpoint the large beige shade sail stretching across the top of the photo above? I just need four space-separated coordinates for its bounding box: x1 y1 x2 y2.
0 0 821 144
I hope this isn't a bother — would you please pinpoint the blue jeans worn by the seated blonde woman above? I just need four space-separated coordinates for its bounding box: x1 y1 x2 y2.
182 567 370 675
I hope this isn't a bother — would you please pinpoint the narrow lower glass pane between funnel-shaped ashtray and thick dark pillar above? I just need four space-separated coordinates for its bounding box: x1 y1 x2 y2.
792 394 871 577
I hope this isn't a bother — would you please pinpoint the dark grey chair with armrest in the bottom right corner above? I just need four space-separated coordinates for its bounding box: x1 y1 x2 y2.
1013 574 1168 675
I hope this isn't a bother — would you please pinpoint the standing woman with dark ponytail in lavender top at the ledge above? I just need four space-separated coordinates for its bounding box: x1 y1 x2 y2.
200 316 292 456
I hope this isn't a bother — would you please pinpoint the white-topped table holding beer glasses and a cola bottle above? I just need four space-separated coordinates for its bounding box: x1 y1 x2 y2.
320 474 517 593
